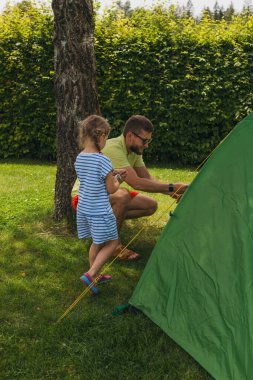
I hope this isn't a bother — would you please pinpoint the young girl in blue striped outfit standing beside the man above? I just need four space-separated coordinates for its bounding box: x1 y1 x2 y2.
75 115 126 294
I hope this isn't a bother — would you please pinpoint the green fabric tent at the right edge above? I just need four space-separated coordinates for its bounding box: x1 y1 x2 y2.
130 113 253 380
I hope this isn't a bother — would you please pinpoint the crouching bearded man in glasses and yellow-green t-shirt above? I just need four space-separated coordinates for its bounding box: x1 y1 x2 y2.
103 115 188 260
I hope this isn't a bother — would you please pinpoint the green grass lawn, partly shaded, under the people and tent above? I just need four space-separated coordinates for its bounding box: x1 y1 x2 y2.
0 161 211 380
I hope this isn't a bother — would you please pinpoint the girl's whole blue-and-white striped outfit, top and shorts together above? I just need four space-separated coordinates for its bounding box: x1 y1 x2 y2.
75 153 118 244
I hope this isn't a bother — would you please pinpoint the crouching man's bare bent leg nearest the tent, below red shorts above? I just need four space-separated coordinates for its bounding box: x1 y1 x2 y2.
125 194 157 219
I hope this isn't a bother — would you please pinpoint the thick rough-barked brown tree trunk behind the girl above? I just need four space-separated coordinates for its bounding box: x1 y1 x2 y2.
52 0 99 221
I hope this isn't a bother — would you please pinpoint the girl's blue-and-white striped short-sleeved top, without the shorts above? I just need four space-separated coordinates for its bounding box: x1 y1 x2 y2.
75 153 113 215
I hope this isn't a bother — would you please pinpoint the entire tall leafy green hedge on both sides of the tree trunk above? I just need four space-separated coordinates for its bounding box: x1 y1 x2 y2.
0 3 253 164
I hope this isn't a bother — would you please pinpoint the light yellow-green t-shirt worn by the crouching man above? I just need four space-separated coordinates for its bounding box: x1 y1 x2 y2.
72 135 145 195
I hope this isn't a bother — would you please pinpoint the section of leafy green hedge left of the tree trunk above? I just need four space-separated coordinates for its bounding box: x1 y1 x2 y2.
0 2 55 159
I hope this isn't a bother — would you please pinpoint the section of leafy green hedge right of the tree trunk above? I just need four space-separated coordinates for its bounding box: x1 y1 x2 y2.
96 9 253 164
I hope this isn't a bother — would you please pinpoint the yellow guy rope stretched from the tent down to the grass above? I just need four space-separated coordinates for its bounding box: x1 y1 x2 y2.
56 139 221 323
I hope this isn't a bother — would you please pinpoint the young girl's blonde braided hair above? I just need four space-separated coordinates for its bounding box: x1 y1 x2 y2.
79 115 111 151
